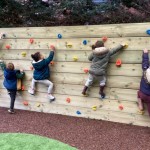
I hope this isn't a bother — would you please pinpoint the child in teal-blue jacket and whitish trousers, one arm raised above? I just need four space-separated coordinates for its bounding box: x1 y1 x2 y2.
28 46 55 102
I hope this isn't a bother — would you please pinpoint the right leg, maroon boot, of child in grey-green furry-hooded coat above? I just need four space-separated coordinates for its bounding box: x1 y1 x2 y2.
99 76 106 98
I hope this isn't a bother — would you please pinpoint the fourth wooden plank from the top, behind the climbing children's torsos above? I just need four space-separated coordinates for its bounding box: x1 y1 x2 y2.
0 60 142 77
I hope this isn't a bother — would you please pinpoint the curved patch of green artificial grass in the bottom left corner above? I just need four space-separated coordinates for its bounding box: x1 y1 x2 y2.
0 133 77 150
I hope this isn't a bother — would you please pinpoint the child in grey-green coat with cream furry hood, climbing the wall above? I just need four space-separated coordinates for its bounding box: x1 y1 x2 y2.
82 41 126 98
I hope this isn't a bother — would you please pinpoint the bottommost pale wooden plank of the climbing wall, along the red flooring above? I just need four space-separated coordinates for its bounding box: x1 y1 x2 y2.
0 98 150 127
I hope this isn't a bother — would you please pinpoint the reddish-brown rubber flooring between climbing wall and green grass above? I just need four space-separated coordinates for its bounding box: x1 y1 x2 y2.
0 108 150 150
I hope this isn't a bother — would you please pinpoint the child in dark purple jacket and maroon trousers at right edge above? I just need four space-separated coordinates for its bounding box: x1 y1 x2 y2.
137 49 150 115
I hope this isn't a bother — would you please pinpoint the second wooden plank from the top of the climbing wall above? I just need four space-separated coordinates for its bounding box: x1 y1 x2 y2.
1 37 150 51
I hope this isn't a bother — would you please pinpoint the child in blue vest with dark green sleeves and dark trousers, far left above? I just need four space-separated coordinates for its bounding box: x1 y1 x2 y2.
0 61 24 114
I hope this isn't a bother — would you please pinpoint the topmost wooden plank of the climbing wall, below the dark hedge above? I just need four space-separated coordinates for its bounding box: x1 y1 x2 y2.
0 23 149 38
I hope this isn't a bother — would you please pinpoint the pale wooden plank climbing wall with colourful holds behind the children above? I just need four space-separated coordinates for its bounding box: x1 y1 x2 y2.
0 23 150 127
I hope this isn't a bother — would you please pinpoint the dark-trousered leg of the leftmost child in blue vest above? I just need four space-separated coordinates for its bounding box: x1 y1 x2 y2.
8 90 17 112
